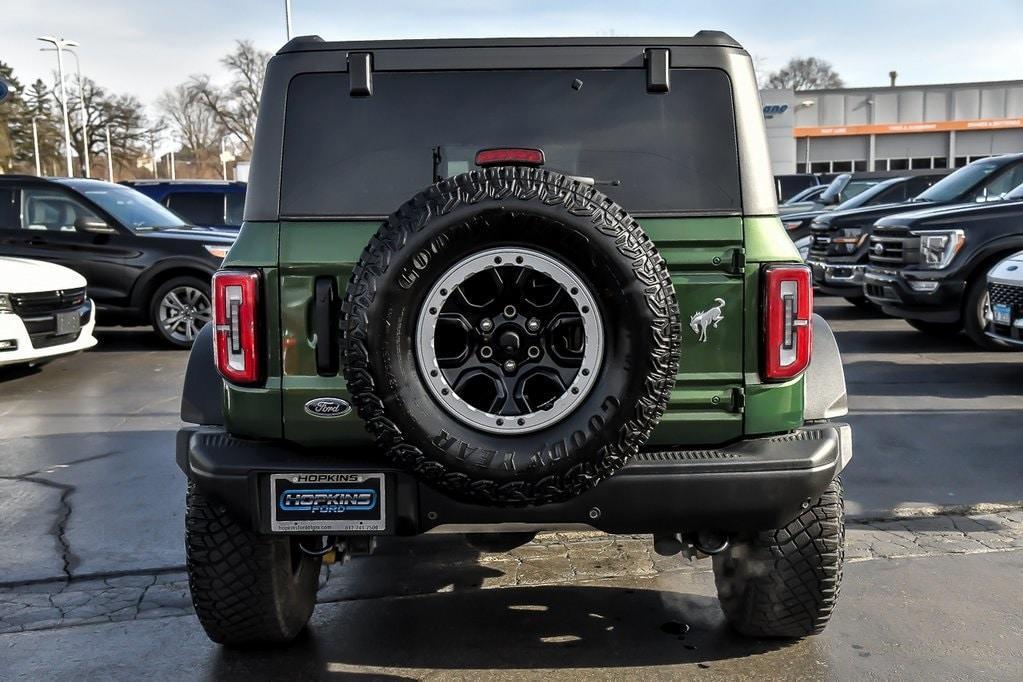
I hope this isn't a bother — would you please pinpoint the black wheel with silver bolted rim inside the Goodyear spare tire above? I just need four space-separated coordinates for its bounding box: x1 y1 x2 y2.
416 247 604 435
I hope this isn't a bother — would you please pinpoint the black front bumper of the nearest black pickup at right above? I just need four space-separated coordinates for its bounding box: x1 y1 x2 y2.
863 267 966 322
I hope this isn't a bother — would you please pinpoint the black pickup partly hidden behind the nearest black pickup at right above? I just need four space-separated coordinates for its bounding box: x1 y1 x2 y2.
806 153 1023 305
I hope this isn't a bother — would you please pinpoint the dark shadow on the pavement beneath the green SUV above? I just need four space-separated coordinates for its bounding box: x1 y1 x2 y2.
205 586 781 679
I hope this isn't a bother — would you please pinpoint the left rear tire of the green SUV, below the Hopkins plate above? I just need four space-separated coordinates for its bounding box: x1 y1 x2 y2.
185 482 320 644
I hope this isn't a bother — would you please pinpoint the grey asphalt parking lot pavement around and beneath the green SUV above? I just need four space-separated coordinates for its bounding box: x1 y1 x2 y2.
0 299 1023 679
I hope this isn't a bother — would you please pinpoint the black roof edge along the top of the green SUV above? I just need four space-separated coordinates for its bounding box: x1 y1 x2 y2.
277 31 742 54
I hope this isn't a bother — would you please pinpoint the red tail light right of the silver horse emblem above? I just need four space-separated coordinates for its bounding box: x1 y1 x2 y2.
762 265 813 381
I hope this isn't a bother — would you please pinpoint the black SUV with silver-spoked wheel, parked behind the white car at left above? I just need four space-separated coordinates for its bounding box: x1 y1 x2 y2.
0 175 234 348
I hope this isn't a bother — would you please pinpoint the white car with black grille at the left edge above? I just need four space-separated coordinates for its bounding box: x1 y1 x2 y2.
0 257 96 366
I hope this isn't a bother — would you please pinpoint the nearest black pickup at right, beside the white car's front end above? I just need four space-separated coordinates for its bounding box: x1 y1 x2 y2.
863 179 1023 350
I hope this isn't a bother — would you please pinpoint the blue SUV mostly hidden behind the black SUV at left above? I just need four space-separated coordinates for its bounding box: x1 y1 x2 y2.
121 180 246 232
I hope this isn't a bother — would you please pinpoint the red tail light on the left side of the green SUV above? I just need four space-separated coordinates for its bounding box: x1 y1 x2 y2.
213 270 263 384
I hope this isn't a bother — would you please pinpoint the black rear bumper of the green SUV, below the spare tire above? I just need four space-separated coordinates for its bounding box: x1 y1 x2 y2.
177 422 852 536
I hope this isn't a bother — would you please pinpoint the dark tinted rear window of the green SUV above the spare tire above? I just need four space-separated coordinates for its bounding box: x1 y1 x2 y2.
280 69 741 217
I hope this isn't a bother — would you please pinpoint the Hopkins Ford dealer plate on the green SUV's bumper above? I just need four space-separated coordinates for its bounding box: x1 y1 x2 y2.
270 472 387 534
